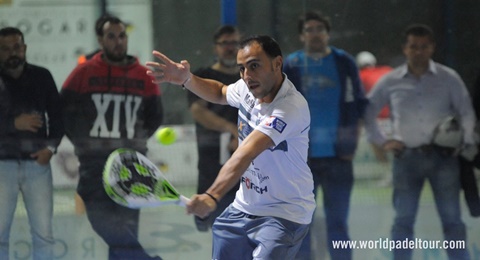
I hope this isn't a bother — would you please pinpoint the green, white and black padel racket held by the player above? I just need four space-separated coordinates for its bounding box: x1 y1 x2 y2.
103 148 190 209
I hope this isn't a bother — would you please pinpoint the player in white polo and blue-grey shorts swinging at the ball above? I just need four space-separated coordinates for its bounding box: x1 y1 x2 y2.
146 36 315 259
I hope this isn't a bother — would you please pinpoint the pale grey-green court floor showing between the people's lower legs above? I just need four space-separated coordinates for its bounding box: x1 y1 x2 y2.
10 180 480 260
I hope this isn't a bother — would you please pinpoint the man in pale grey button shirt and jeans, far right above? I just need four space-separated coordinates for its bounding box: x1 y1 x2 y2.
365 24 476 260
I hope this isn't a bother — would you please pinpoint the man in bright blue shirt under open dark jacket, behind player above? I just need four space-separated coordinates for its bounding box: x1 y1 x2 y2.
284 12 367 259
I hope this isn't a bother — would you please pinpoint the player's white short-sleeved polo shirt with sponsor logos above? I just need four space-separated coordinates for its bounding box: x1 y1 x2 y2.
227 76 316 224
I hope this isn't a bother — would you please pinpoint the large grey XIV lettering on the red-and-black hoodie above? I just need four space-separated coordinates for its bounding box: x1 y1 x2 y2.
90 94 142 139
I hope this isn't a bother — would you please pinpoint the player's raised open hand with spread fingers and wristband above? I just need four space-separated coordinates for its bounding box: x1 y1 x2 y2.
146 51 192 85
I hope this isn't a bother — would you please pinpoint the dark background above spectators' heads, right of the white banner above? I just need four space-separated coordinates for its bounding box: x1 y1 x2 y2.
146 0 480 124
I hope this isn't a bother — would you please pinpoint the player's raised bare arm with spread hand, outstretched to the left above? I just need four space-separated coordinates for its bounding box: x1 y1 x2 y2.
146 51 227 105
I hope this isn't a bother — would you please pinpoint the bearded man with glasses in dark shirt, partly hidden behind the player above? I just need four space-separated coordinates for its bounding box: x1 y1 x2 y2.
188 25 240 231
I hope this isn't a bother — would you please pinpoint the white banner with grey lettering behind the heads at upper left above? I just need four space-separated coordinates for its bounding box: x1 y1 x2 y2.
0 0 153 88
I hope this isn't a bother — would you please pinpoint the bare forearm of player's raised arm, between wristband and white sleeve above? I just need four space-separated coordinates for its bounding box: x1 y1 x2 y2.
183 74 227 105
